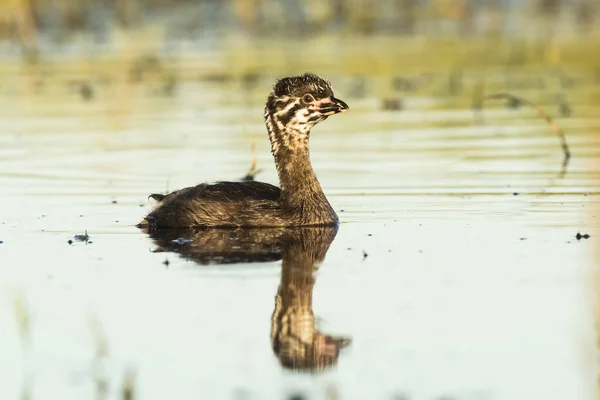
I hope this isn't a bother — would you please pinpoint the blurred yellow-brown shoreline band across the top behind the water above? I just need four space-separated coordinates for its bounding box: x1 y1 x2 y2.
0 0 600 68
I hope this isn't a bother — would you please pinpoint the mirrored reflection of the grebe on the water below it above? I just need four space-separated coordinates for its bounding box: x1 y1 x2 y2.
144 226 351 372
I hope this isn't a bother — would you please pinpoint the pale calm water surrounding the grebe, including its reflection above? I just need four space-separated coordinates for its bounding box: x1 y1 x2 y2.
0 65 600 400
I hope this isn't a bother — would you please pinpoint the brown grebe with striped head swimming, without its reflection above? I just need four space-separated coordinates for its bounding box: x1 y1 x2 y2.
139 73 348 229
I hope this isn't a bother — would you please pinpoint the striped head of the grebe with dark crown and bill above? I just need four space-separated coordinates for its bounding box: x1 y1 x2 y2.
265 73 349 147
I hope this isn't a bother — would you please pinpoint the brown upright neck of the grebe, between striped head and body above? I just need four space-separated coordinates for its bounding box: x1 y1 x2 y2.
266 114 337 223
